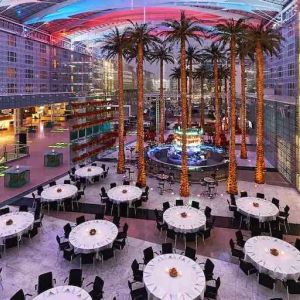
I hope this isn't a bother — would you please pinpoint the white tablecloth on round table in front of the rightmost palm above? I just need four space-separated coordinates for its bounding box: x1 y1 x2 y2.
236 197 279 222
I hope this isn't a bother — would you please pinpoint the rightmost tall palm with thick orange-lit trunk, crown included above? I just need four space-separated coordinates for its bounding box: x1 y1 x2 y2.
246 22 283 184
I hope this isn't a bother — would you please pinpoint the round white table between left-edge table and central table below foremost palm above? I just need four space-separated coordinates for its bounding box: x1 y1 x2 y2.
69 220 118 253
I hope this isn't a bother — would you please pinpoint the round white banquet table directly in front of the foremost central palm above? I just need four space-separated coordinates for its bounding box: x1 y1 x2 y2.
163 206 206 233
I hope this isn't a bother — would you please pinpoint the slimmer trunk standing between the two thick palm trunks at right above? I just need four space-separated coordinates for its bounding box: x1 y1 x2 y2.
240 53 247 159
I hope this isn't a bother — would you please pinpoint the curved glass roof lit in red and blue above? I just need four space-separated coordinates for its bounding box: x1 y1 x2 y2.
0 0 291 39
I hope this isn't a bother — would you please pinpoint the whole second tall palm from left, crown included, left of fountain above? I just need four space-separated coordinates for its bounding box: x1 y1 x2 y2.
126 21 158 186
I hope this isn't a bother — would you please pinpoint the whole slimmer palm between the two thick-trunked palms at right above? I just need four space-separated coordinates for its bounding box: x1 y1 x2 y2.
237 35 254 159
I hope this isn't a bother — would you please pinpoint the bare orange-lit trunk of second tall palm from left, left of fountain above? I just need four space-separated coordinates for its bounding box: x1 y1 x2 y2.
137 43 146 186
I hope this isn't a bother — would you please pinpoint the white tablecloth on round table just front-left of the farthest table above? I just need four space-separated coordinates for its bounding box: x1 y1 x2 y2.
41 184 78 202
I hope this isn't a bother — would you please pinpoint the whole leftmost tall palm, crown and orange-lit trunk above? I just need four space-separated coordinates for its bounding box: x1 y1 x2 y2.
101 27 128 174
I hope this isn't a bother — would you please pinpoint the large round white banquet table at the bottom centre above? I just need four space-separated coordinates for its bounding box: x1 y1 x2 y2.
143 254 205 300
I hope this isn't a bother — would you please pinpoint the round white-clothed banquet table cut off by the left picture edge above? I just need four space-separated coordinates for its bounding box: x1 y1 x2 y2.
0 211 34 241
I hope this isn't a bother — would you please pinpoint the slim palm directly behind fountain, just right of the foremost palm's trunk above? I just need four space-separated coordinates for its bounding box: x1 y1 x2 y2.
186 44 201 127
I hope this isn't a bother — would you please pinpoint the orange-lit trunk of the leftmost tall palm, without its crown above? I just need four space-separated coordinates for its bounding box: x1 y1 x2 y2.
117 49 125 174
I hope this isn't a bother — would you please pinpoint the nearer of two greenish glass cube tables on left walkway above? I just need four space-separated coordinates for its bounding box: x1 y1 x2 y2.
4 166 30 188
